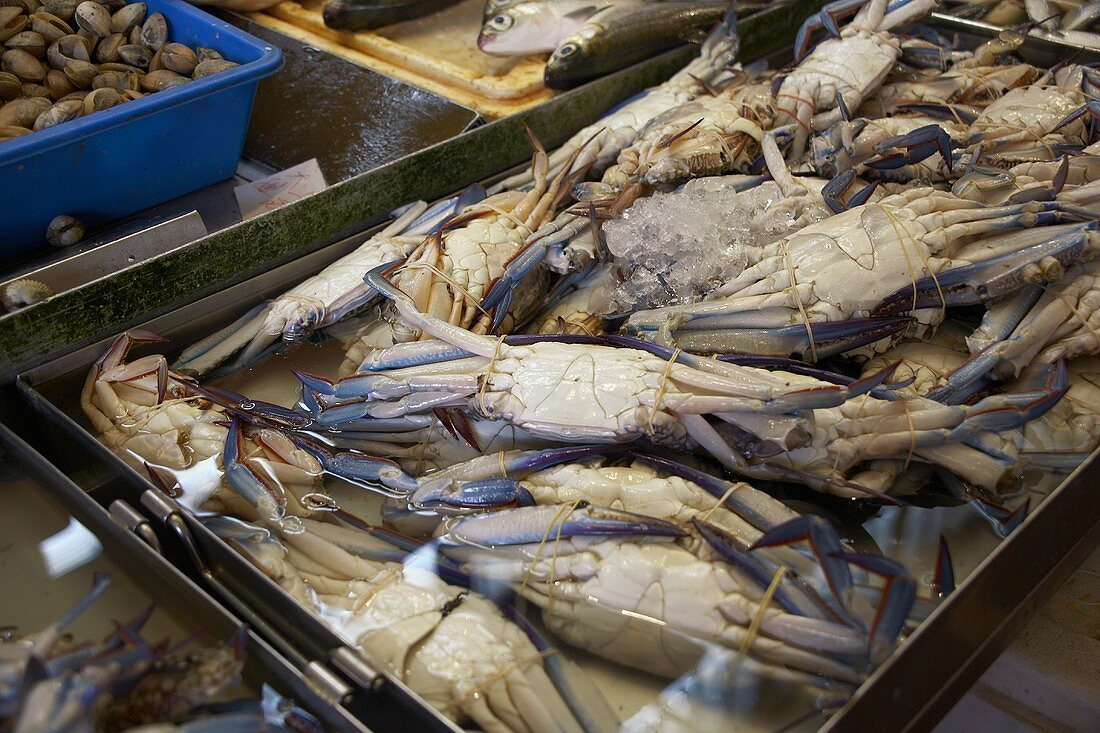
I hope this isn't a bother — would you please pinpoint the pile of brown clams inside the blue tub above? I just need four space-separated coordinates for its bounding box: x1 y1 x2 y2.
0 0 237 142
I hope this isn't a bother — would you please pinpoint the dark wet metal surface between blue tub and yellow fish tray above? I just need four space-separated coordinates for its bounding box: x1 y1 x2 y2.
227 14 477 184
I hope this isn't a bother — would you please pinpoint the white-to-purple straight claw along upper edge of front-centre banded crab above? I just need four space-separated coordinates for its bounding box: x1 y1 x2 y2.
447 505 688 547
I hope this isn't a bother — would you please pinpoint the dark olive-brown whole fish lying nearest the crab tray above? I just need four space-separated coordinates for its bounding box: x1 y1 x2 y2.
545 2 727 89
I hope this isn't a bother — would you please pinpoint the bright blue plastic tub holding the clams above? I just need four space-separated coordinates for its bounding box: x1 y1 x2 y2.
0 0 283 259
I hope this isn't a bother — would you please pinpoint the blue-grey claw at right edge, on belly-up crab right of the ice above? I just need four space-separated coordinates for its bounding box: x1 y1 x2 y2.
871 221 1098 316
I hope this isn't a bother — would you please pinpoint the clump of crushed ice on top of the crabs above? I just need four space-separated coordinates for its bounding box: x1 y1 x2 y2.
604 176 827 313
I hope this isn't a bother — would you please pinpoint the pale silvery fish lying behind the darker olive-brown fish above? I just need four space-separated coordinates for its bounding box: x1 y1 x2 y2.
477 0 607 56
